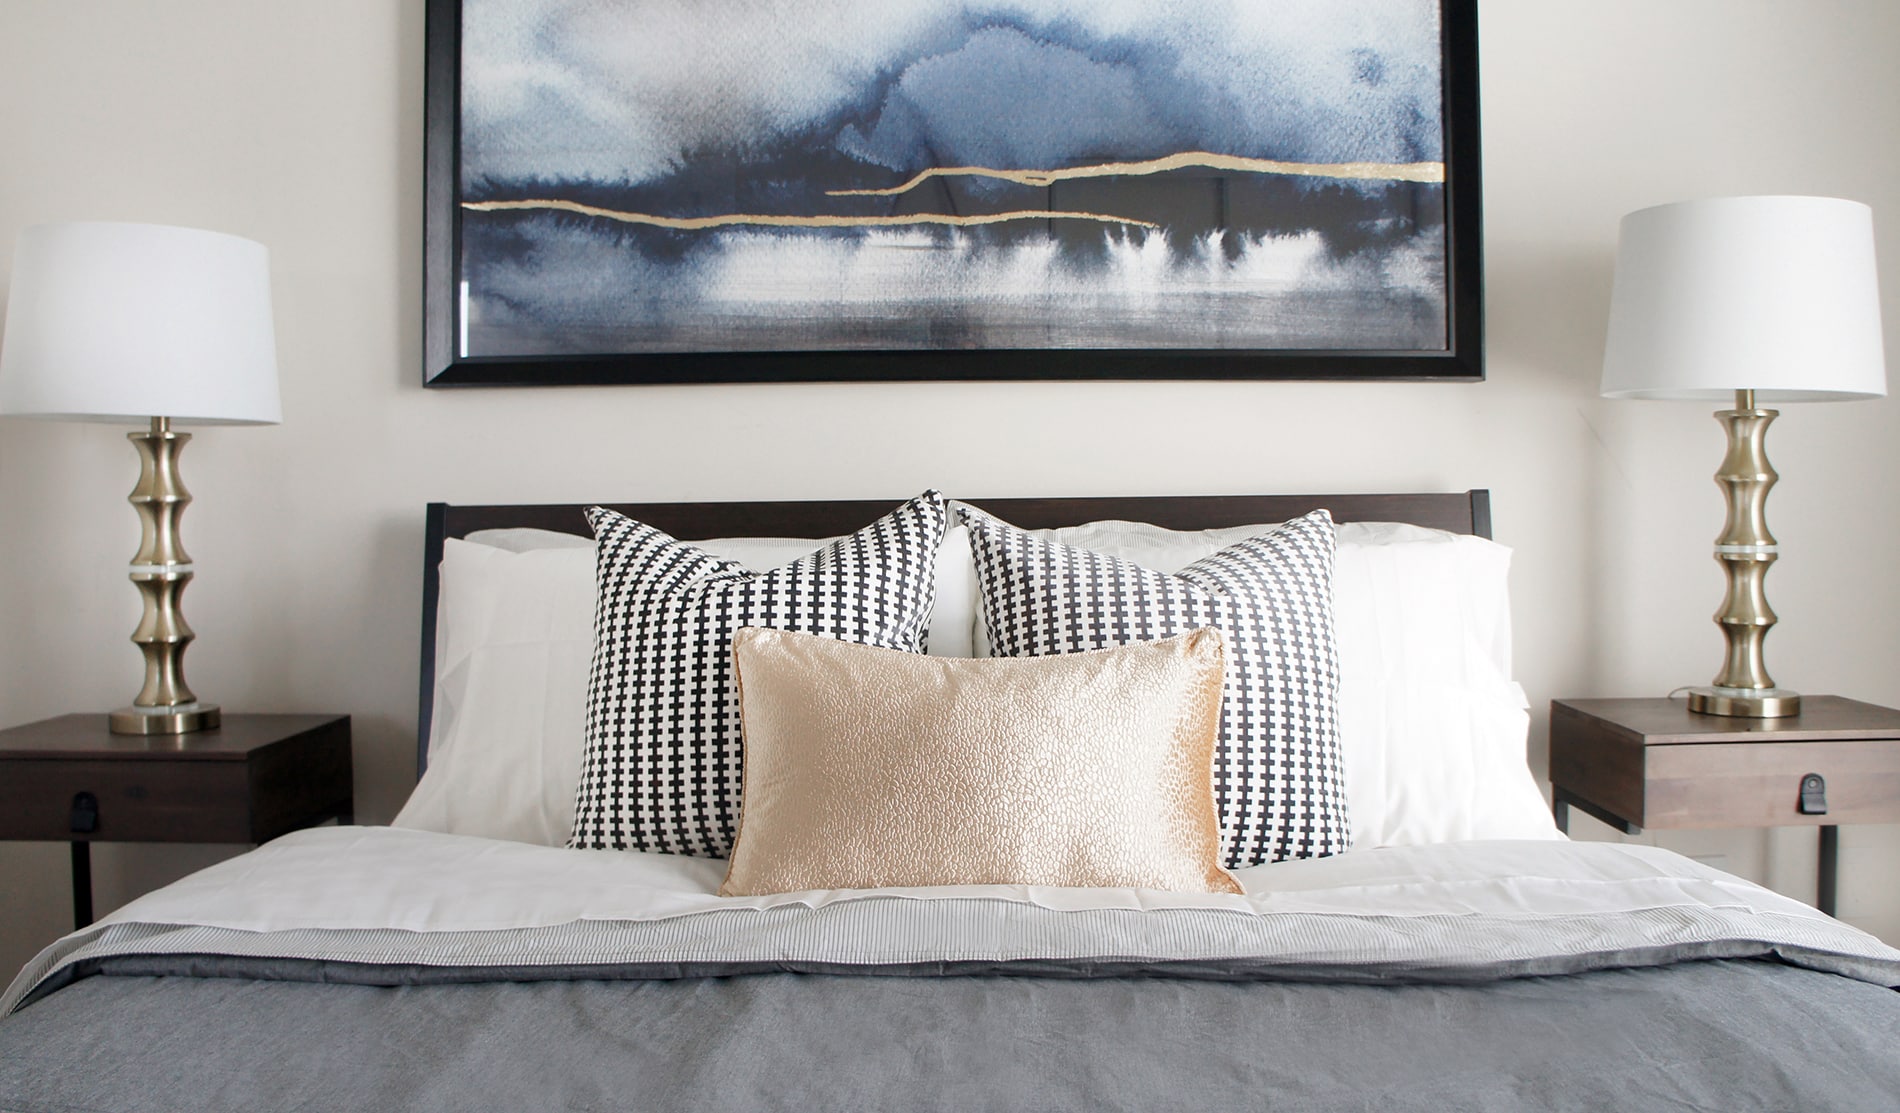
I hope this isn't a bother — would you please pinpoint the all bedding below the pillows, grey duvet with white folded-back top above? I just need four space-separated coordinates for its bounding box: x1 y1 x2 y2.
0 828 1900 1111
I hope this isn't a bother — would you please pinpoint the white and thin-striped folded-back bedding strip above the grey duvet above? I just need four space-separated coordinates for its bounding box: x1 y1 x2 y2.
0 828 1900 1010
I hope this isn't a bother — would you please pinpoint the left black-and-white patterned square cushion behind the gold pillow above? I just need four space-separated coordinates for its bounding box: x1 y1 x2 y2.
568 490 950 858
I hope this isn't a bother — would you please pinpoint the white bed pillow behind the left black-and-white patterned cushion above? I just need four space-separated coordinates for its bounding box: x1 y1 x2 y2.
391 526 977 835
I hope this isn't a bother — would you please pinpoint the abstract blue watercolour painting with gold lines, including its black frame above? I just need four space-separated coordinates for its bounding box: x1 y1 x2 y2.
424 0 1484 386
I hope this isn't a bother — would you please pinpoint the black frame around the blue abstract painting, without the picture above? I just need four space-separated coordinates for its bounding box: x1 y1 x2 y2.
422 0 1484 387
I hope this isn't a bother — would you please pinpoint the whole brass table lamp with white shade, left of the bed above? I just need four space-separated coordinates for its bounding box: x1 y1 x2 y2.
0 222 283 735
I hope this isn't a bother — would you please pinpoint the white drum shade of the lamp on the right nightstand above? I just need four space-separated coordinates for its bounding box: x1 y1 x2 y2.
1604 198 1887 405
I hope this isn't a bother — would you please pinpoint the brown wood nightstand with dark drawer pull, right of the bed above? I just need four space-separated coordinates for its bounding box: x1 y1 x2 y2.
1550 695 1900 915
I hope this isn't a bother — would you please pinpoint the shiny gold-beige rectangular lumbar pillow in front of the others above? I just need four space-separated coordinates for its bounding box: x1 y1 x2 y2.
720 629 1241 896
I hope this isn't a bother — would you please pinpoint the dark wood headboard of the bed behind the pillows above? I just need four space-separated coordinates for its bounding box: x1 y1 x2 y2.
416 490 1492 773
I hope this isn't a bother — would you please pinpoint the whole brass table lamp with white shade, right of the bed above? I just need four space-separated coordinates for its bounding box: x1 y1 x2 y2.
1604 198 1887 718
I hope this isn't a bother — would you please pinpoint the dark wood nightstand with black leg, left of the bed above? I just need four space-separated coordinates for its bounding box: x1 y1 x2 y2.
0 712 355 927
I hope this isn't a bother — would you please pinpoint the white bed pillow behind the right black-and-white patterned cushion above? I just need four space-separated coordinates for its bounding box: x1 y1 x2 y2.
977 520 1564 847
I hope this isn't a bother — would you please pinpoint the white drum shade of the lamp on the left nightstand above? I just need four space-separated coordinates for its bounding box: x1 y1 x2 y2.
0 222 283 425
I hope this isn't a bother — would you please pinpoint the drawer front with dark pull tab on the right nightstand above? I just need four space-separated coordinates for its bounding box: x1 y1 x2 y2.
1632 739 1900 828
